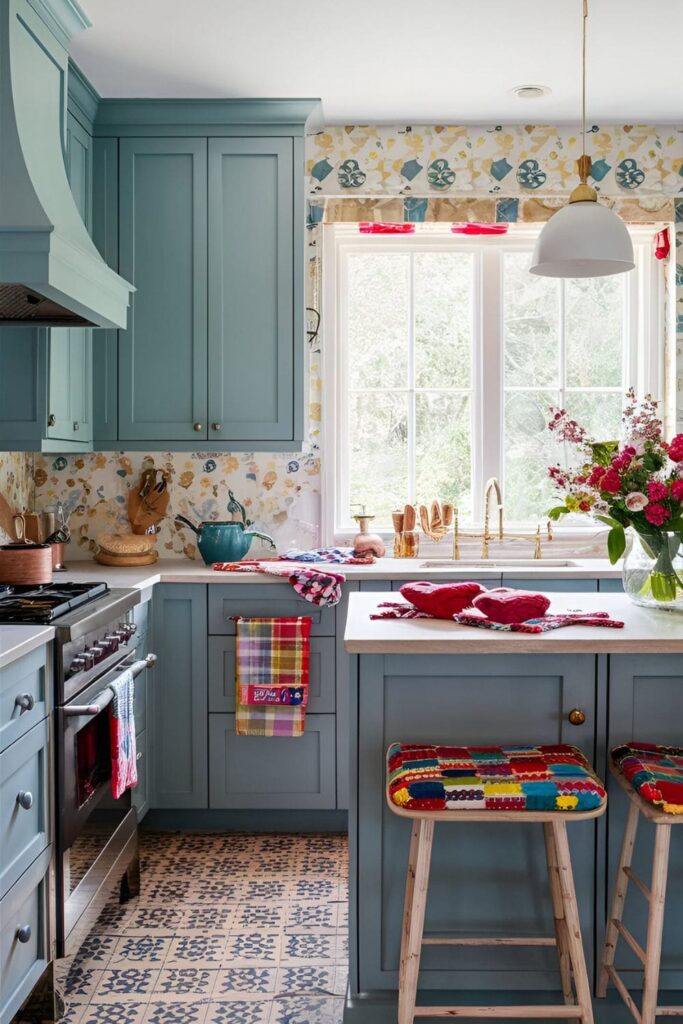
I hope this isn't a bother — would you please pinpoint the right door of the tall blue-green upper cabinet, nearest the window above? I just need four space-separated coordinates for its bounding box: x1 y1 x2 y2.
209 138 294 440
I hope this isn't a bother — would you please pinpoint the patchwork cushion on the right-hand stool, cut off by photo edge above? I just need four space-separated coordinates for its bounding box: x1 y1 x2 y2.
612 740 683 814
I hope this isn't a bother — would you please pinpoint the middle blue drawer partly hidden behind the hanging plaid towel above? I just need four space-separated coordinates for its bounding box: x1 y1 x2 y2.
209 637 335 715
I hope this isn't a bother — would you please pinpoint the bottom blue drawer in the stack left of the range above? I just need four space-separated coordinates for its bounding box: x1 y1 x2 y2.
0 847 52 1024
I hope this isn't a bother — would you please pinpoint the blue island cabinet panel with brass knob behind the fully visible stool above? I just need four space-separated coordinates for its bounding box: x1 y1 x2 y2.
356 654 595 991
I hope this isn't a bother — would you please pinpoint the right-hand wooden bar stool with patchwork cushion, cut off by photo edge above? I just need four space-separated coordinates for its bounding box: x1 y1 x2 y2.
597 742 683 1024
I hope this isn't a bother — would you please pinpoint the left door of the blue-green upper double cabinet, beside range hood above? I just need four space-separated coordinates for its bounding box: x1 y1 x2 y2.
119 138 207 443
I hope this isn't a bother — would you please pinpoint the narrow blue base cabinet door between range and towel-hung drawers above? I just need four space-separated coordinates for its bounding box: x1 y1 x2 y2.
152 584 208 808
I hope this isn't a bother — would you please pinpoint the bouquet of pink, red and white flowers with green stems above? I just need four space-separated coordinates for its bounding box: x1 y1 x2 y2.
548 388 683 603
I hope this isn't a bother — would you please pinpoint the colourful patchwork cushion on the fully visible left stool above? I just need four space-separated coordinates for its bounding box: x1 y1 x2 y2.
387 743 605 811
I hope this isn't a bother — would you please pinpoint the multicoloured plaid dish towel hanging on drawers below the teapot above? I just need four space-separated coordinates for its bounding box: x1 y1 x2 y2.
234 615 311 736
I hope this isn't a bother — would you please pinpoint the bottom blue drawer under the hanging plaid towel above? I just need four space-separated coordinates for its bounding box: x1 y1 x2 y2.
209 715 336 810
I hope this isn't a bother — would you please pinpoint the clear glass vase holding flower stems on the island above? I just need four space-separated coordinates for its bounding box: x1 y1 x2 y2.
624 529 683 611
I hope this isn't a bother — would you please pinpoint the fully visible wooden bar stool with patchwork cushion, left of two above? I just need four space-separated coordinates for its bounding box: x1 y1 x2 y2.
386 743 606 1024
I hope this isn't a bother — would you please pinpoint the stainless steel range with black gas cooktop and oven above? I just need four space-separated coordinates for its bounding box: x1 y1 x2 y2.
0 584 156 956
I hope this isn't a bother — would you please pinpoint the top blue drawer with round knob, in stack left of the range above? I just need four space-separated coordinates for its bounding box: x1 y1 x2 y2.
0 644 52 751
